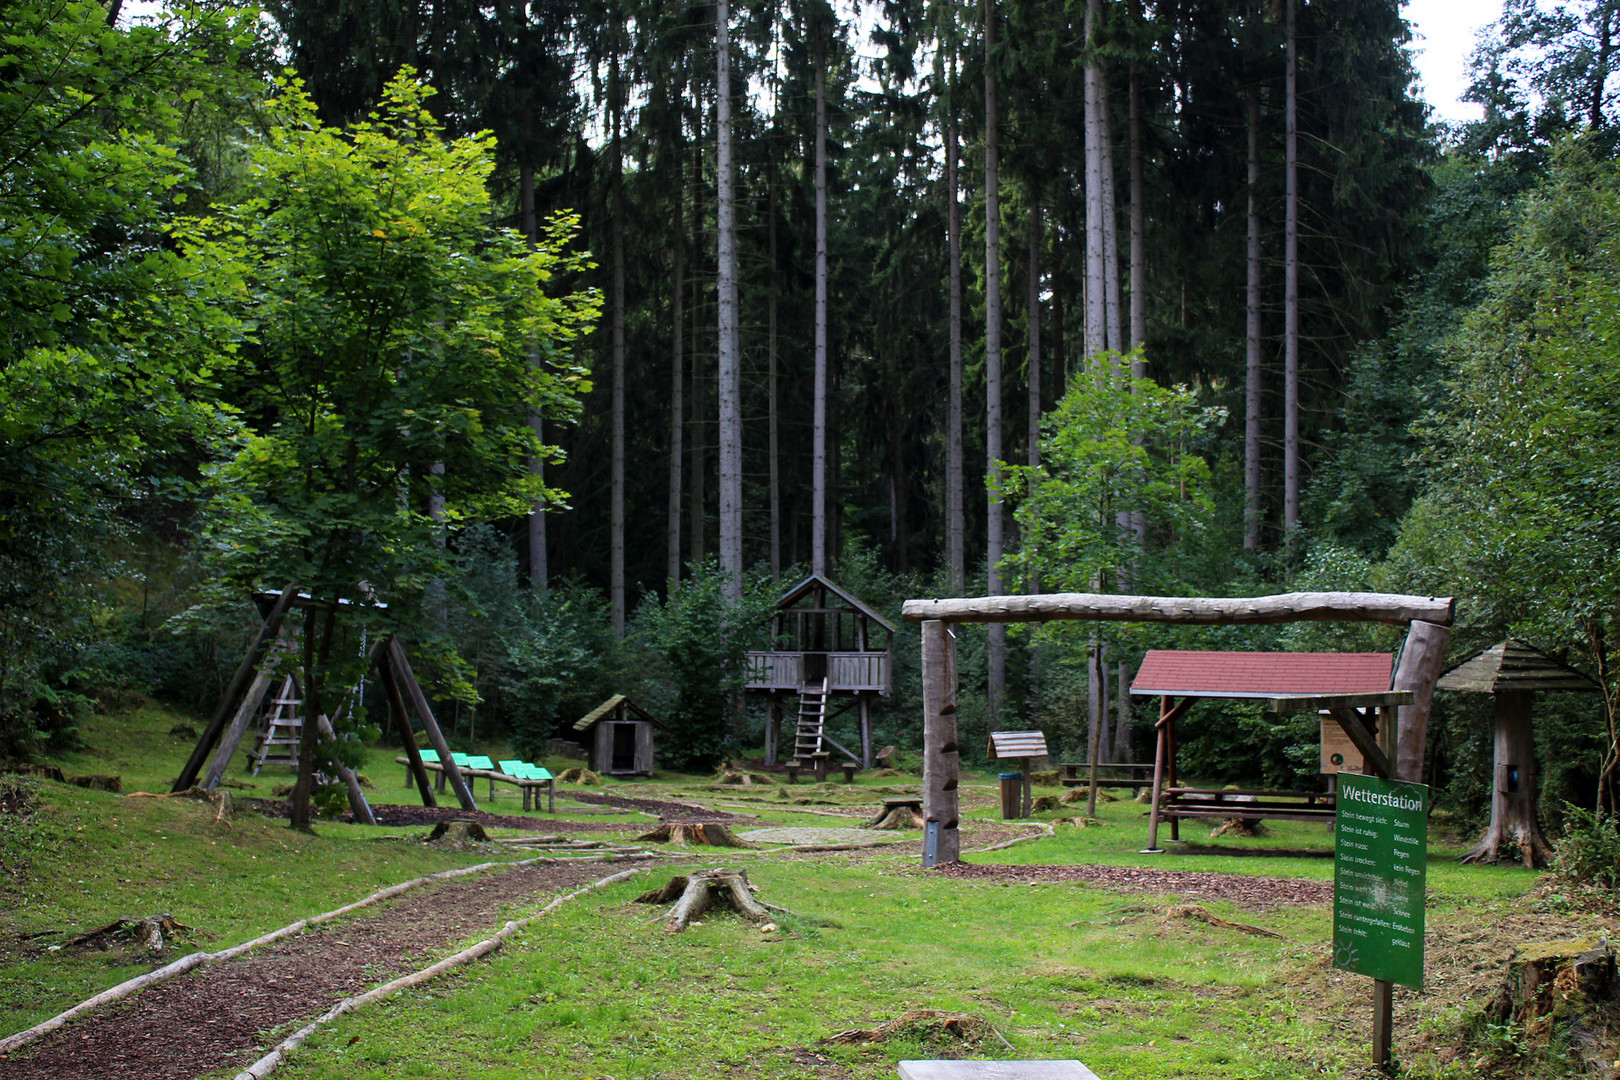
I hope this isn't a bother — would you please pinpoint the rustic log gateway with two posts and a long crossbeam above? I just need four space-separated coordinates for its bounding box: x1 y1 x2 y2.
901 593 1455 866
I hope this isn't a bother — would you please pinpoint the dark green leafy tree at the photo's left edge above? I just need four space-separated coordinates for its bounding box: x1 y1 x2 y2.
0 0 253 759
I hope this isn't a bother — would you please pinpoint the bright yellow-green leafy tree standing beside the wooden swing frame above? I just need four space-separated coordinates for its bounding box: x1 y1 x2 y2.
177 71 596 827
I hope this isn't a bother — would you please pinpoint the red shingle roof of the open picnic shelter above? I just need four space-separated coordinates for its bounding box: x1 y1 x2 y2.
1131 649 1393 698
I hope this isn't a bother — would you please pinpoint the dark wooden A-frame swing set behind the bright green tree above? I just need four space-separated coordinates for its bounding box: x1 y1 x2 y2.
172 585 478 824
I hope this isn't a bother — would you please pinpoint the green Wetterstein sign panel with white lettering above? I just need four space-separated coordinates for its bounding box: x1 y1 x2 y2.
1333 772 1429 988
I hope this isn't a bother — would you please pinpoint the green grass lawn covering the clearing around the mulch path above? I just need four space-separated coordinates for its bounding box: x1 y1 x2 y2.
0 708 1614 1080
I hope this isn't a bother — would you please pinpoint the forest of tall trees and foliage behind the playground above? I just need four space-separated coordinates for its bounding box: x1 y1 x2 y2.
0 0 1620 841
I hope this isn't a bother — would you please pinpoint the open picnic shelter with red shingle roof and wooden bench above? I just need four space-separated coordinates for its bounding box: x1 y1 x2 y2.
1131 649 1411 852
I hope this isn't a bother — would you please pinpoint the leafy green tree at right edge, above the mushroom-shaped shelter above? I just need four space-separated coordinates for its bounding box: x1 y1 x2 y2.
1392 139 1620 813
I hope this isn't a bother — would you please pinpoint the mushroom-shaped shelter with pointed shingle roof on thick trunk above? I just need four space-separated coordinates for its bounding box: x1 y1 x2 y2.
1435 638 1601 866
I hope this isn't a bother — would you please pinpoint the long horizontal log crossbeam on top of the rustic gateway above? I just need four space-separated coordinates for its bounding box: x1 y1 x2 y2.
901 593 1455 627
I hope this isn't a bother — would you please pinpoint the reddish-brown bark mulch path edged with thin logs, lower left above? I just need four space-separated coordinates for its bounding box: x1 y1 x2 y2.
0 861 644 1080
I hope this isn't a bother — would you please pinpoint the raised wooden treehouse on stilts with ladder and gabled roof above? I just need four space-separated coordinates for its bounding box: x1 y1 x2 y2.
744 573 894 769
